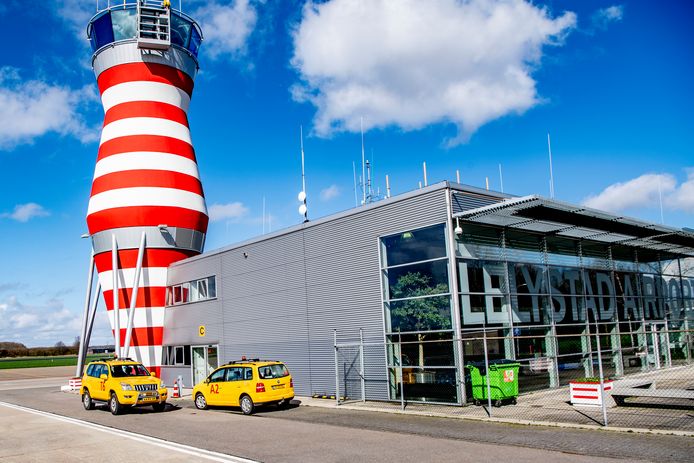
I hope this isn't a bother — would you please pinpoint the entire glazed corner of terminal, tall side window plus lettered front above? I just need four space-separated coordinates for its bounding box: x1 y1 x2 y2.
381 219 694 403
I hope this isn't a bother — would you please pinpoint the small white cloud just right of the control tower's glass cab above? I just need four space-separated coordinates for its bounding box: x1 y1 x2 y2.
193 0 258 58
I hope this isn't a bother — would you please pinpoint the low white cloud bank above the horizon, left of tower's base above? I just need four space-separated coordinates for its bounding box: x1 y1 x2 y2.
0 296 81 346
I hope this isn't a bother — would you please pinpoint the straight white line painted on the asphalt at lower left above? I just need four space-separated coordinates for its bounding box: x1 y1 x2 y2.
0 402 259 463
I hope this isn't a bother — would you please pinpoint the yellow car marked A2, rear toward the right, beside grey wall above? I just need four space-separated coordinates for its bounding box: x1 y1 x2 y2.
193 359 294 415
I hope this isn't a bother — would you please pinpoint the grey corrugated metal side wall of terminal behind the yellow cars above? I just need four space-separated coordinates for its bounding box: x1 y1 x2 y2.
164 187 494 399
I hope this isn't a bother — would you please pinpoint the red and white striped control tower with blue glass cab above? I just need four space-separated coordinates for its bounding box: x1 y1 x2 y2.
77 0 208 376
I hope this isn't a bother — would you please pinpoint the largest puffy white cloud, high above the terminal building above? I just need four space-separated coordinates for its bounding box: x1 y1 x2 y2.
291 0 576 144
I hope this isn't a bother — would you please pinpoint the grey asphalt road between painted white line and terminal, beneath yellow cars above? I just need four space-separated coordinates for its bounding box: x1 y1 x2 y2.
0 374 694 463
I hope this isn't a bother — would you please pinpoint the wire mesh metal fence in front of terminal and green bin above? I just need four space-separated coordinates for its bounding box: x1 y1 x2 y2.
334 321 694 431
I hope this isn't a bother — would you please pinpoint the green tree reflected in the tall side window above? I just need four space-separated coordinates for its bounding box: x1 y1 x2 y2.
390 272 451 368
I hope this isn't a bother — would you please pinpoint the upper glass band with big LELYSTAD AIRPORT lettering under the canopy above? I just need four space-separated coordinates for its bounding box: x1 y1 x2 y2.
456 225 694 326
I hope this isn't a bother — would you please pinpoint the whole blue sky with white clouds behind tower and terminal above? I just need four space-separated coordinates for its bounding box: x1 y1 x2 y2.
0 0 694 345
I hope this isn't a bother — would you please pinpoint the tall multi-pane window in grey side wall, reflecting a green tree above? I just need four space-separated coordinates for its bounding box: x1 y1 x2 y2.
381 224 457 403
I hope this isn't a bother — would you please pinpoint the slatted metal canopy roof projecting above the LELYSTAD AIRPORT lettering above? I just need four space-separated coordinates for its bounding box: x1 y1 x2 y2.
453 195 694 256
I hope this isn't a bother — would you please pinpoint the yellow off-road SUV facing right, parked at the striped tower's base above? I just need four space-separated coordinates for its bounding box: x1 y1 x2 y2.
80 359 167 415
